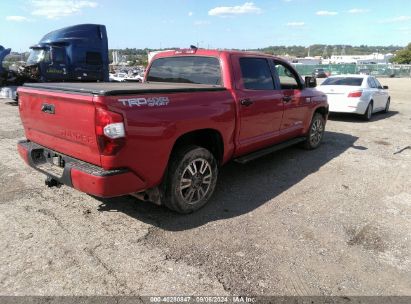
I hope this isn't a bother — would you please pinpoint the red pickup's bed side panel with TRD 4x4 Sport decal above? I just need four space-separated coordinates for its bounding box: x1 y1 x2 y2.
95 90 235 188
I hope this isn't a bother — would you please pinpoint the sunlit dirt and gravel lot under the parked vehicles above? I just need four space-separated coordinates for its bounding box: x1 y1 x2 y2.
0 79 411 295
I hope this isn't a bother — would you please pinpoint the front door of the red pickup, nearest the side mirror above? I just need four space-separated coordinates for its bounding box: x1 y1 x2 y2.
273 60 308 135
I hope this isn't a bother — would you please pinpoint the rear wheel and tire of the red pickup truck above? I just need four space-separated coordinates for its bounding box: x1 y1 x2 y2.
163 146 218 214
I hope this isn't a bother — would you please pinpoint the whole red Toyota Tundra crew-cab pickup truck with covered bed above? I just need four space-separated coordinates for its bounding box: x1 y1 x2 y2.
18 49 328 213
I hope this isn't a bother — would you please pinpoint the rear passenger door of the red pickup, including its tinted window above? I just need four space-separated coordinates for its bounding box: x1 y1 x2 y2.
232 55 284 154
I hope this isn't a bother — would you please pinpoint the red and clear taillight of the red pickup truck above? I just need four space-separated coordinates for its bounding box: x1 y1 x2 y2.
96 108 126 156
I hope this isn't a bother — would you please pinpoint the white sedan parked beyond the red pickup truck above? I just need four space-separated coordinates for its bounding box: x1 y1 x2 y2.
318 75 390 120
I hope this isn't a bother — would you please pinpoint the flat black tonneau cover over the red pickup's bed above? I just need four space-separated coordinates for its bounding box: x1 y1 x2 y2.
24 82 225 96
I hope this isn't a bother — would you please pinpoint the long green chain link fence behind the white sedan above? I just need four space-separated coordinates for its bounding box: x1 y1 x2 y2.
294 64 411 77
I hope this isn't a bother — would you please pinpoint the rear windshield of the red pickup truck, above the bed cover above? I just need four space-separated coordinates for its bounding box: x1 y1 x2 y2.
147 56 221 85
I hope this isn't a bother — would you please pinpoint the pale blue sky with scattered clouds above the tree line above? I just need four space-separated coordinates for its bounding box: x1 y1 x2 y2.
0 0 411 52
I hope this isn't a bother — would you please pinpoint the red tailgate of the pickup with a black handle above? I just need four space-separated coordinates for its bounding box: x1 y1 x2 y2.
19 87 101 166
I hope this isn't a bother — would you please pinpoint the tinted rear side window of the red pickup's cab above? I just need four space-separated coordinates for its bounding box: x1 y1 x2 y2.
240 57 274 90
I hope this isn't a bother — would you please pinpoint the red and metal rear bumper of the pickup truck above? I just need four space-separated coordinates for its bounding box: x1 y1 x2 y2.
17 141 145 197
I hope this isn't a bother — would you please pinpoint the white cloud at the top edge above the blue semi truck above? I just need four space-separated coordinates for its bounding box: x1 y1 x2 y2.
31 0 97 19
